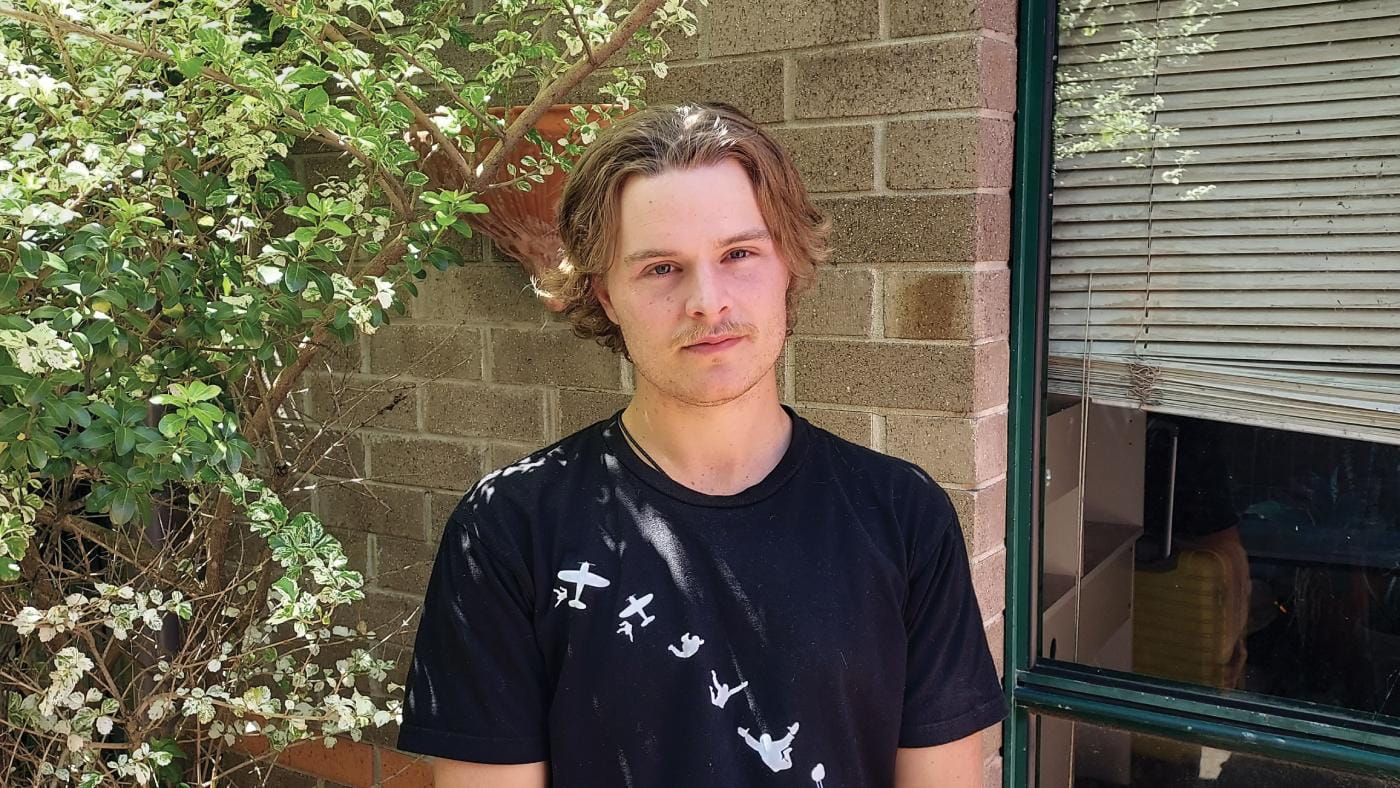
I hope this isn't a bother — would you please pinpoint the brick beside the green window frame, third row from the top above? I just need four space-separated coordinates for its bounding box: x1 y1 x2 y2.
885 118 1012 189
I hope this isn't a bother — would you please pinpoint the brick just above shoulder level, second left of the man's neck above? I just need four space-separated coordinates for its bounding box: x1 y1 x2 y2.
423 381 545 441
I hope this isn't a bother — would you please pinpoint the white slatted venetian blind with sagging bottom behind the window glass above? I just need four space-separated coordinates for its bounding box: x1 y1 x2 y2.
1050 0 1400 442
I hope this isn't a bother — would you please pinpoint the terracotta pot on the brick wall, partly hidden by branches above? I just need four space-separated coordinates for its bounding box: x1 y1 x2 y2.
409 104 621 312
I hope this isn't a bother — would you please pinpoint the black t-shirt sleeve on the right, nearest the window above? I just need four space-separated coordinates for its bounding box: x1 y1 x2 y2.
899 480 1007 747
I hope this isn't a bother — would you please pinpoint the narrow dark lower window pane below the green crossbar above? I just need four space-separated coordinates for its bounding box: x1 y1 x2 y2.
1030 714 1394 788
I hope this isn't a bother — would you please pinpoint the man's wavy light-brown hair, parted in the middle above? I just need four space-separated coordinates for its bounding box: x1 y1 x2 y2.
535 102 832 358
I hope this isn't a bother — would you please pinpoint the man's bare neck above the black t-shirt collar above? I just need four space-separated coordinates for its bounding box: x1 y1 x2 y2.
623 377 792 495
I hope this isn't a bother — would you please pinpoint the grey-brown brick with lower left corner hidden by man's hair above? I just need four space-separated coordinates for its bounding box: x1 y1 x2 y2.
755 126 875 193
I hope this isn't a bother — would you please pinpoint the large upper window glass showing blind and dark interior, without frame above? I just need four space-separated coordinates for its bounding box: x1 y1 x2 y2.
1039 0 1400 725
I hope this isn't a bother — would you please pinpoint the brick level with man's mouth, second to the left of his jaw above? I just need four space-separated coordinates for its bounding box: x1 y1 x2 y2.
370 323 482 381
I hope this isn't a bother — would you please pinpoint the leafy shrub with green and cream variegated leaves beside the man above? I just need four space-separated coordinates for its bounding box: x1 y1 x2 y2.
0 0 703 785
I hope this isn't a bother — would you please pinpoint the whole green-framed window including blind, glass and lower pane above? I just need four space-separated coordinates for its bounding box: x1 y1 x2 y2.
1005 0 1400 788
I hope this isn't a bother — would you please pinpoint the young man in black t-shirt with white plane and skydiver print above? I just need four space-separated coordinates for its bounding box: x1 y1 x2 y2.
399 104 1005 788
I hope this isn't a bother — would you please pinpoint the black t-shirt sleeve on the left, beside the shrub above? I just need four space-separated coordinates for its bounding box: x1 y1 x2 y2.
398 498 549 763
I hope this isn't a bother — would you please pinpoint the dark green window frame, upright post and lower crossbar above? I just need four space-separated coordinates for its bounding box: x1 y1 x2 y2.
1002 0 1400 788
